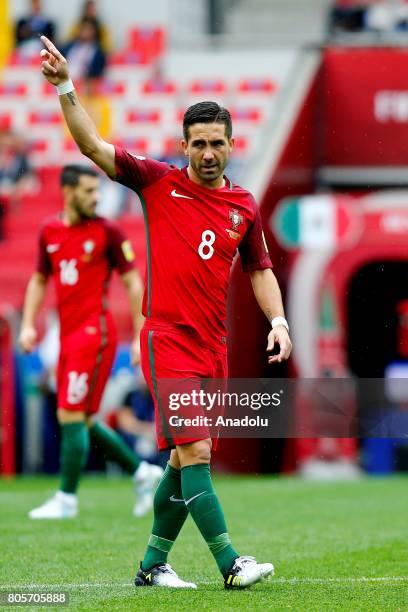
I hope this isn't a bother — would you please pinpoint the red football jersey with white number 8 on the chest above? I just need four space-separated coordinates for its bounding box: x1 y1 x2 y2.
115 147 272 351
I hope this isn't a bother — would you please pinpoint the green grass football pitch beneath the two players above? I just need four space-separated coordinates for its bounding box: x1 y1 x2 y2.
0 476 408 612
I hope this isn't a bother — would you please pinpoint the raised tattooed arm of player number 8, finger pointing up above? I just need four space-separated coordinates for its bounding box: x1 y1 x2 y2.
41 36 115 177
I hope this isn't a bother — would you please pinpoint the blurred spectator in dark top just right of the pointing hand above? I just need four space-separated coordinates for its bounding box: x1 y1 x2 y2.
62 17 106 81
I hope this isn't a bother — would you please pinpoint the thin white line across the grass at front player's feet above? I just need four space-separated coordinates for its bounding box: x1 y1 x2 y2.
0 576 408 591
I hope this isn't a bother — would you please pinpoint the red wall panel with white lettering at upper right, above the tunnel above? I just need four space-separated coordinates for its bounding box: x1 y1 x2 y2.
321 48 408 167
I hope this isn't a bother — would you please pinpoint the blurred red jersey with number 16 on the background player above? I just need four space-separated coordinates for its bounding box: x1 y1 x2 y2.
37 217 134 337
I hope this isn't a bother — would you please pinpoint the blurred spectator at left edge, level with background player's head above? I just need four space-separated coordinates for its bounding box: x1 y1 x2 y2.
0 127 35 237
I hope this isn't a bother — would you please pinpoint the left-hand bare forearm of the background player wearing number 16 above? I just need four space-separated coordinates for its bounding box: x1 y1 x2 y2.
19 272 48 353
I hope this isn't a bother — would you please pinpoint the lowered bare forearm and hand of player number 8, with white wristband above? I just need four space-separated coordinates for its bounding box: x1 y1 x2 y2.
250 268 292 363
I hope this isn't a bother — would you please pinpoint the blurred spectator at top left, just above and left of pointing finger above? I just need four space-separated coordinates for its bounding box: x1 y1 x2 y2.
15 0 55 55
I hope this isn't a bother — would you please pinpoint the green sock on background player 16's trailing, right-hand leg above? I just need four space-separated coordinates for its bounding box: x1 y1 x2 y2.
89 422 141 474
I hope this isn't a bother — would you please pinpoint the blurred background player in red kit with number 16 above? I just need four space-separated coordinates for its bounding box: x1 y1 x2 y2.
20 165 163 519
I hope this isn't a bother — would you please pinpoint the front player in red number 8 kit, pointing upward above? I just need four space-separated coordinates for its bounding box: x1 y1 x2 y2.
41 37 291 588
